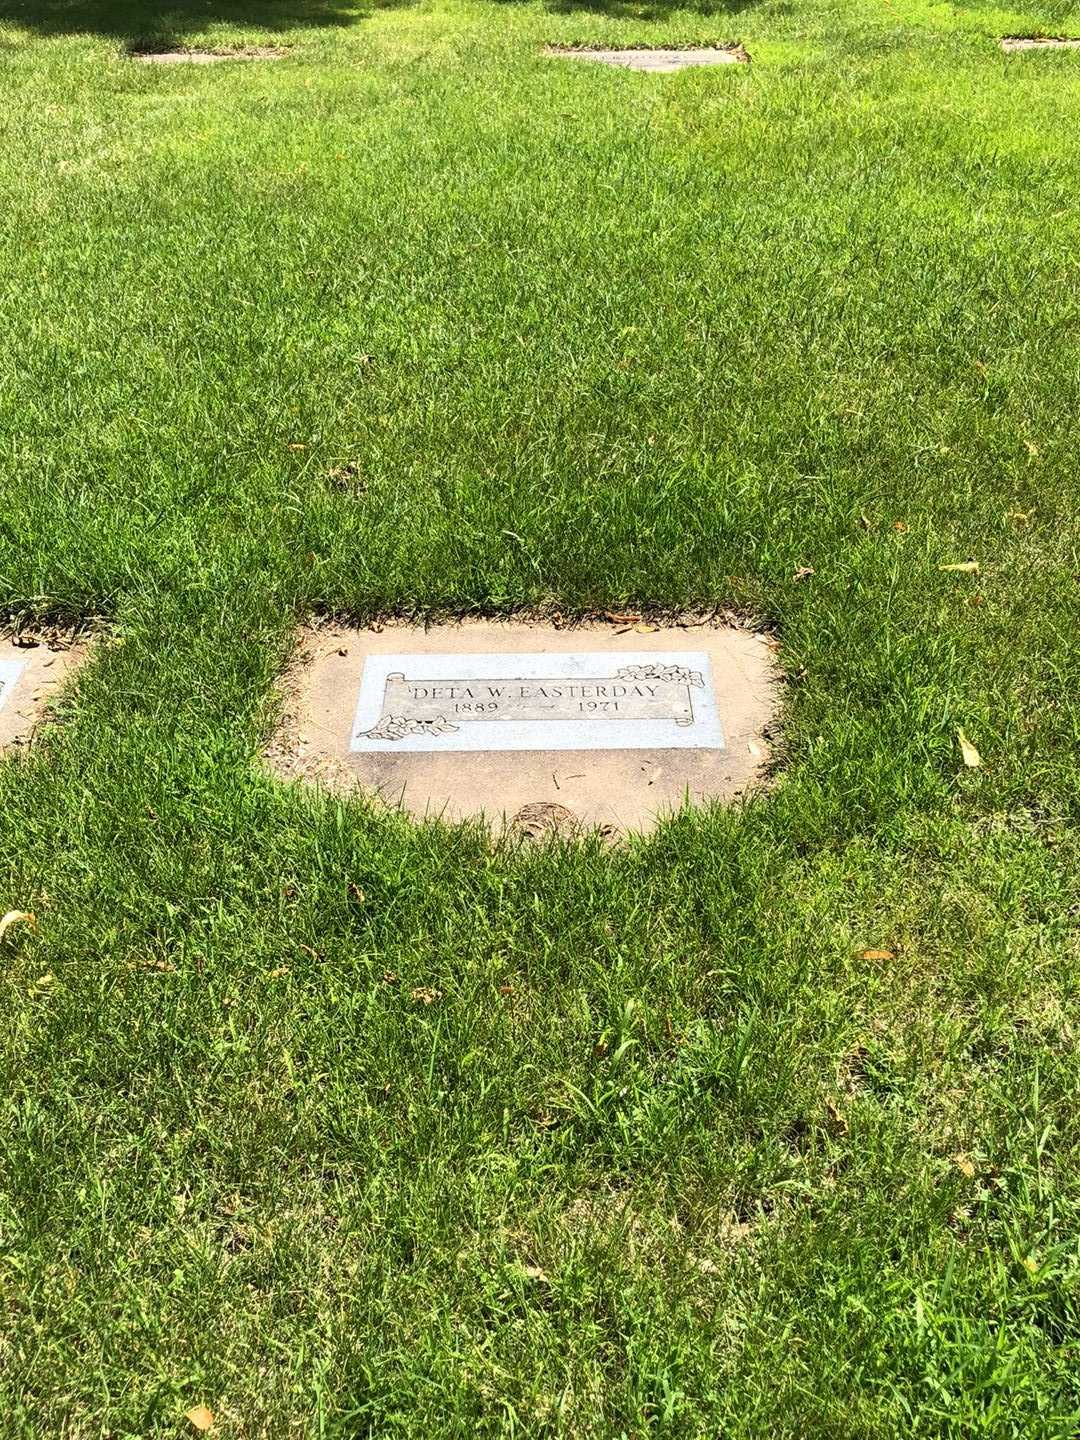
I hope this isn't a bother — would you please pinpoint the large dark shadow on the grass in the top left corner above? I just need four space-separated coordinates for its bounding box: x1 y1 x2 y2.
0 0 384 46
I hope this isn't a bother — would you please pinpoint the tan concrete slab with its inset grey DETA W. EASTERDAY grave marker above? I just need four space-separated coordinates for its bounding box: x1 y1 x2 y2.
266 621 778 835
